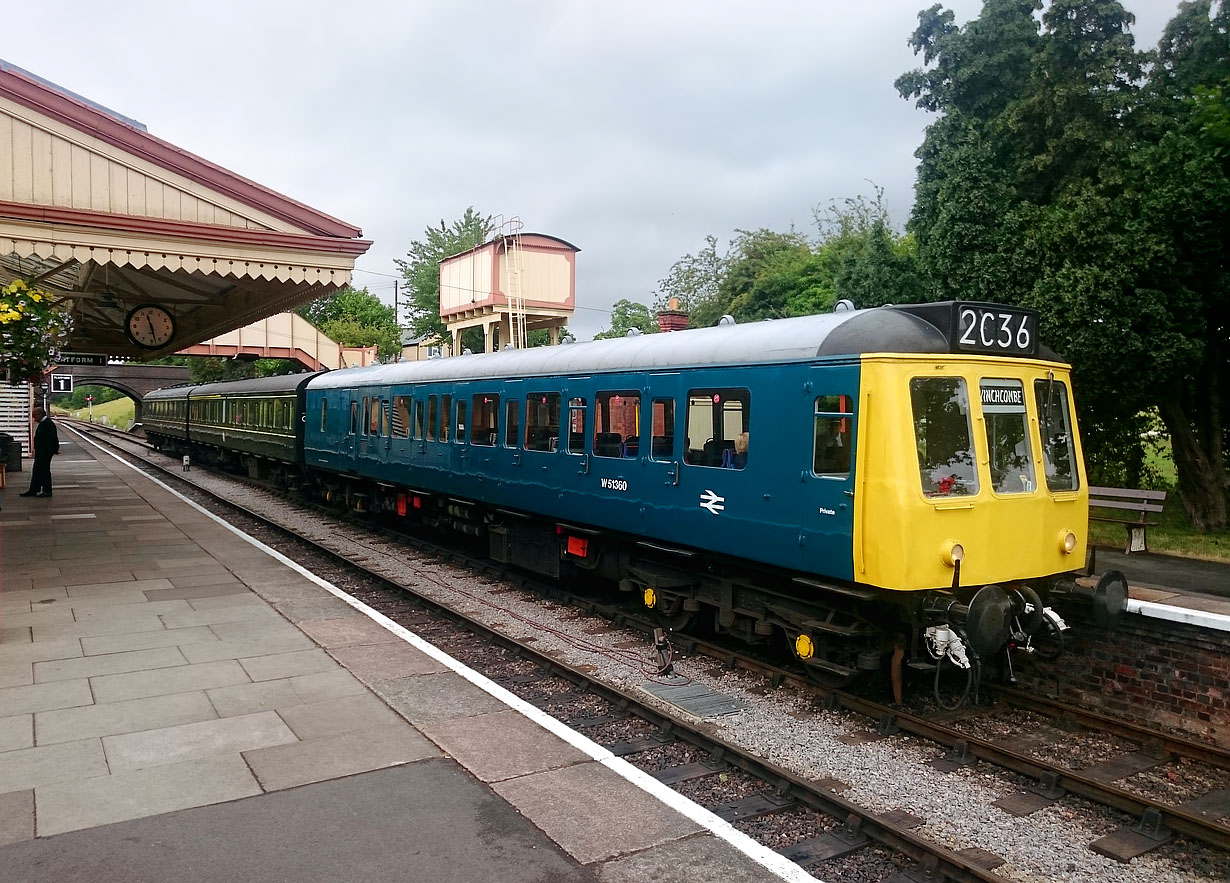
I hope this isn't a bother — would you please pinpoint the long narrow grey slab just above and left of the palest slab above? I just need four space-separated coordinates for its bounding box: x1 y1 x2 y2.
34 691 218 745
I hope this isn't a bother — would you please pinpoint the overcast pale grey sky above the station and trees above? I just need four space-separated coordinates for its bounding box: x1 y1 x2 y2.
11 0 1177 339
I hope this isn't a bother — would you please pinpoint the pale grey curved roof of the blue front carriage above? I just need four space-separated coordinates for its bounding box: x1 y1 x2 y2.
305 301 1054 395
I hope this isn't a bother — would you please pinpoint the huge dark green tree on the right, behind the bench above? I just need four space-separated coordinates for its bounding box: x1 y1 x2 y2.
897 0 1230 529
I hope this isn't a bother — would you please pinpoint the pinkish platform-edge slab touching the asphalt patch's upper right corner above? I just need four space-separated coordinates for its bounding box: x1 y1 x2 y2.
421 711 589 782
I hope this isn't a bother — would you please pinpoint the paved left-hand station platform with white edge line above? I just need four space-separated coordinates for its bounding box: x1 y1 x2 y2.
0 428 812 883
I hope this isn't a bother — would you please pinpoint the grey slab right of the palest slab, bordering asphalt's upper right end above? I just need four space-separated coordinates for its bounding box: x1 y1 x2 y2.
244 723 440 791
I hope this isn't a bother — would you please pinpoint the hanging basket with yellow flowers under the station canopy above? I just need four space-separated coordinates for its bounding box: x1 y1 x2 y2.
0 279 73 384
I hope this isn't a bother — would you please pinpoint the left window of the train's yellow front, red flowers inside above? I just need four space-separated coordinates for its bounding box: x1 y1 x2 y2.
910 378 978 497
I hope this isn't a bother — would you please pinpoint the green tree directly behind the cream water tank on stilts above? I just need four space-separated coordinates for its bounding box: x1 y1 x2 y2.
395 205 494 352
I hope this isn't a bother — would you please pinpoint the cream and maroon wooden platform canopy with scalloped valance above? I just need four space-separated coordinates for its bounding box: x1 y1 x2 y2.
0 60 371 359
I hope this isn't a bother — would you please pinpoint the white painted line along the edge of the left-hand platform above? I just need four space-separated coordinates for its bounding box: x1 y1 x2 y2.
65 427 823 883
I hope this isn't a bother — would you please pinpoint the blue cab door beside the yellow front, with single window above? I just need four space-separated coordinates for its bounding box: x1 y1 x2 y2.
790 365 859 579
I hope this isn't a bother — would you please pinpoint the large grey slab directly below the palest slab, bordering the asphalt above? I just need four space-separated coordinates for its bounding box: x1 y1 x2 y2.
32 755 261 841
